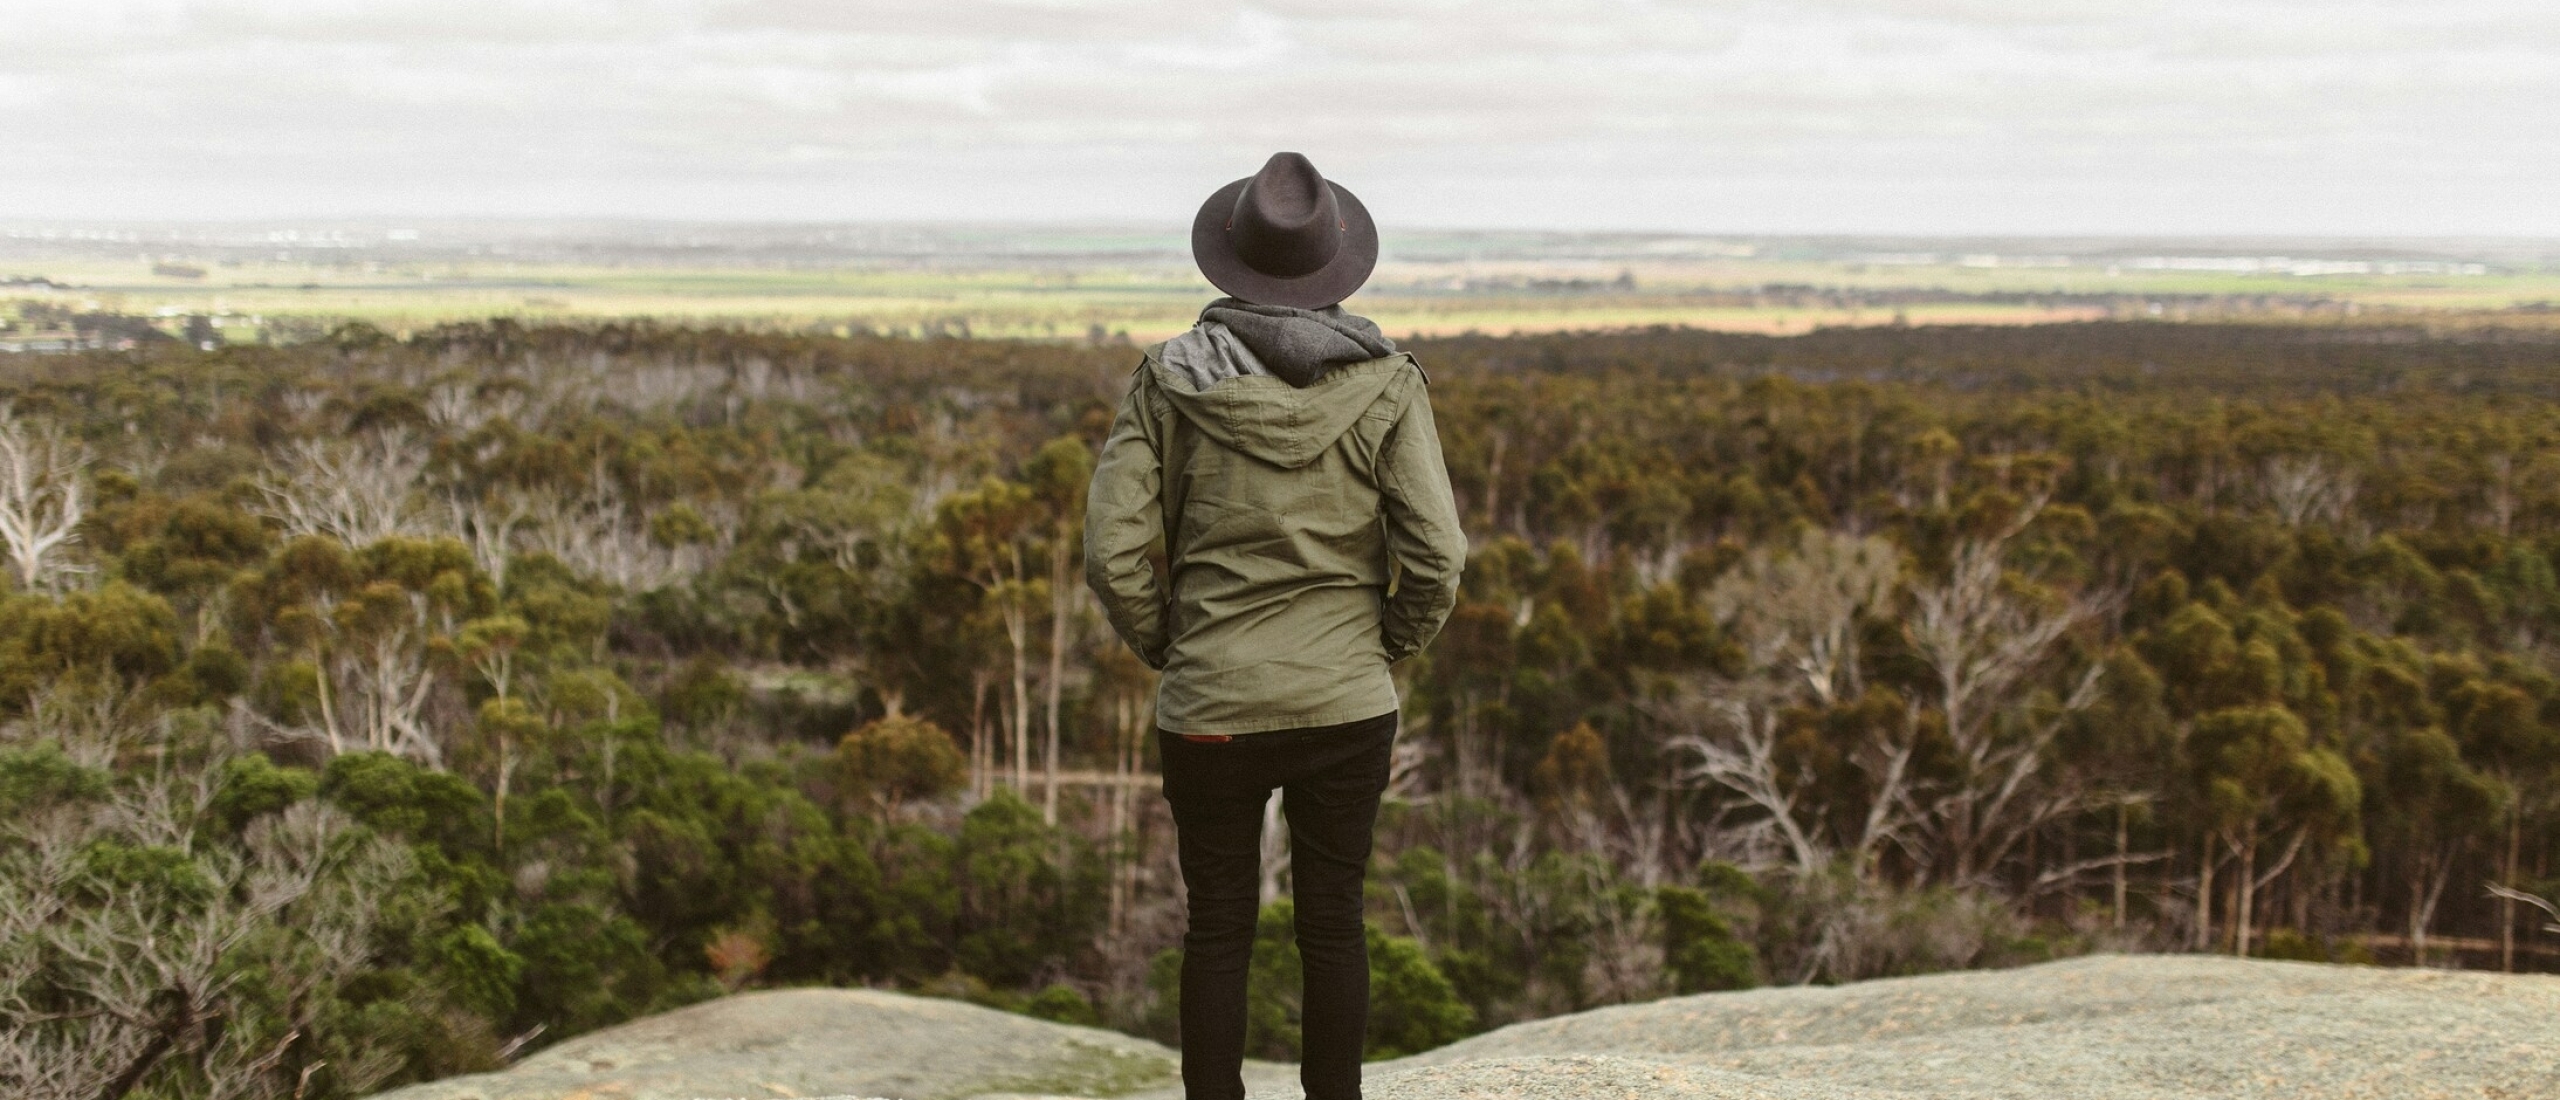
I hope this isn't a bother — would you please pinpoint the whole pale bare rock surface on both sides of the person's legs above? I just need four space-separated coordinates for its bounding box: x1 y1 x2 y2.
387 957 2560 1100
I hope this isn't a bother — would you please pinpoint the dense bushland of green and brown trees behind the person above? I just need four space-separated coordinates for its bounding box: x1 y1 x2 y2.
0 322 2560 1097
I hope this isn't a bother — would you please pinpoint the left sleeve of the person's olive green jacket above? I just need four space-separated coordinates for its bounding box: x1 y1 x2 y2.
1085 366 1172 670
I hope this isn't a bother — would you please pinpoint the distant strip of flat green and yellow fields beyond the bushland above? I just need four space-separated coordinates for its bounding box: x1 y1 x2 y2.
0 256 2560 340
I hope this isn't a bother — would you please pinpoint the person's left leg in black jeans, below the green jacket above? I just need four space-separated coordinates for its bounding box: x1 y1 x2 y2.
1157 732 1270 1100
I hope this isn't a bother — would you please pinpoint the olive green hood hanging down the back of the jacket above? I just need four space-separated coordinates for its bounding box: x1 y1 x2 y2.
1144 345 1421 471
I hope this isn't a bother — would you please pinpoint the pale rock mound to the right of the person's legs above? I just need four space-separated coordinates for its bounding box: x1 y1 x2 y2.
1375 954 2560 1100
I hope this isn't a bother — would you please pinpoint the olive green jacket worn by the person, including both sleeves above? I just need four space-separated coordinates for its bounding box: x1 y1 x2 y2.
1085 345 1467 734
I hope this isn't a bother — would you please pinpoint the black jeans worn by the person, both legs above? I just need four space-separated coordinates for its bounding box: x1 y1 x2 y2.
1155 714 1395 1100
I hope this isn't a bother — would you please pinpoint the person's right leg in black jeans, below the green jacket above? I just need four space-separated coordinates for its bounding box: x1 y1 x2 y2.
1280 714 1395 1100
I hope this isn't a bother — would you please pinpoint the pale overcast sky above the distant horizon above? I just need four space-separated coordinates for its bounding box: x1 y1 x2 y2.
0 0 2560 235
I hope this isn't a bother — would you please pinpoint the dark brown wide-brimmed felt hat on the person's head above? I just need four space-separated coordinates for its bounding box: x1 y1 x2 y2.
1190 153 1377 310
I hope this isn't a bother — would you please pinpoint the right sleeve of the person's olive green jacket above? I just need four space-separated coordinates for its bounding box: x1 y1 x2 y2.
1377 373 1467 663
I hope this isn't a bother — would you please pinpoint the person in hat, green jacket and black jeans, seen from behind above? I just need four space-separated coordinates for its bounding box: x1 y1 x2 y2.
1085 153 1467 1100
